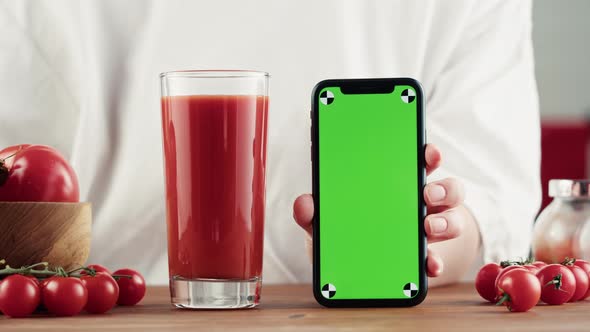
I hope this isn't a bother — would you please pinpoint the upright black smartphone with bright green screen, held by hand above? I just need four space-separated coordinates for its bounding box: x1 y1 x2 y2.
311 78 428 307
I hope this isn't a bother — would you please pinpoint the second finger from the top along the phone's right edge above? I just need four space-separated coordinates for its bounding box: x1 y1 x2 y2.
424 178 465 208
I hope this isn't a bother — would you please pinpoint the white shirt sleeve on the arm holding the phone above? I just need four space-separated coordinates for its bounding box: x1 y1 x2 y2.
426 1 541 262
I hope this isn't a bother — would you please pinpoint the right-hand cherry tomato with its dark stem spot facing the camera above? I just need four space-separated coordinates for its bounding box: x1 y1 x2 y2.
537 264 576 305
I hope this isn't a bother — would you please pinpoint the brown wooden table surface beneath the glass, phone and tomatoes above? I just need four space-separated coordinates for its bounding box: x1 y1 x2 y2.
0 284 590 332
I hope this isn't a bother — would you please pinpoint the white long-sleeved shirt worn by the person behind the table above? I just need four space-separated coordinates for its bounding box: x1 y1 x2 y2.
0 0 540 283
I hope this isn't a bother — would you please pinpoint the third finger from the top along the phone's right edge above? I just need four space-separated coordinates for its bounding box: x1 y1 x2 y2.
424 206 469 243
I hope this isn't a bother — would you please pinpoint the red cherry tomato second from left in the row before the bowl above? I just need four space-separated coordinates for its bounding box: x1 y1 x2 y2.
41 277 88 316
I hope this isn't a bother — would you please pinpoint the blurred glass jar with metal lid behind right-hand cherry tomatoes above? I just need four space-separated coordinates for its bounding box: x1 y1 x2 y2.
533 180 590 263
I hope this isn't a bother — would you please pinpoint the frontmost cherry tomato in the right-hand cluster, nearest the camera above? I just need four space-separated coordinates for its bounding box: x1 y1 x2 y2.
497 269 541 312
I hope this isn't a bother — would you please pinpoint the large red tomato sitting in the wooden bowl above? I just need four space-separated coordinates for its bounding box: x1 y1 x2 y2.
0 144 80 202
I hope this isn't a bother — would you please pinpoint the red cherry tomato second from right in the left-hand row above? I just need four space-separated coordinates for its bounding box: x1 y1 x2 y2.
80 272 119 314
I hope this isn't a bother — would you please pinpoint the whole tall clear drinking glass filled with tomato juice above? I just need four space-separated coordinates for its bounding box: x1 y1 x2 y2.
160 70 269 309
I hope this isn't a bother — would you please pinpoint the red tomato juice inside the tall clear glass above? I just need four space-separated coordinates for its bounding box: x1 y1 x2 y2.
162 95 268 280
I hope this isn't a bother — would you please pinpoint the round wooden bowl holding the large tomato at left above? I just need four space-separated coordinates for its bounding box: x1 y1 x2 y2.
0 202 92 270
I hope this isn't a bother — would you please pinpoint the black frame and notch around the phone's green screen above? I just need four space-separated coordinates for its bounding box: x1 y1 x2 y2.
310 78 428 307
